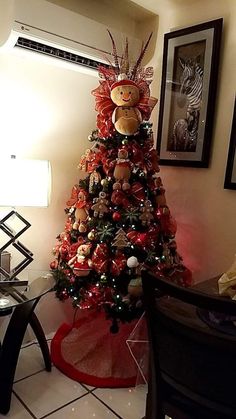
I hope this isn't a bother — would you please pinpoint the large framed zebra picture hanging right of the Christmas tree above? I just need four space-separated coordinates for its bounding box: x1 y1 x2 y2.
157 18 223 167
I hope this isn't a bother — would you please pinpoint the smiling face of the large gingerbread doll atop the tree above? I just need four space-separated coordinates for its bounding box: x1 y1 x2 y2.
111 85 139 106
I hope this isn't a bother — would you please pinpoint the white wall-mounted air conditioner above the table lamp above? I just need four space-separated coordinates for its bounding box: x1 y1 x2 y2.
0 0 141 74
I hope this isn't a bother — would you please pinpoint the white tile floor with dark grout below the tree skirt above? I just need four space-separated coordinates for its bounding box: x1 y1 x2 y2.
0 341 147 419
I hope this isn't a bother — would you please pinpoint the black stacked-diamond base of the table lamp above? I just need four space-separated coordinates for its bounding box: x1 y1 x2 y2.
0 210 33 280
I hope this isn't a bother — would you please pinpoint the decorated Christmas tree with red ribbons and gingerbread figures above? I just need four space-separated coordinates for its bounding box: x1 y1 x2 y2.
51 34 191 331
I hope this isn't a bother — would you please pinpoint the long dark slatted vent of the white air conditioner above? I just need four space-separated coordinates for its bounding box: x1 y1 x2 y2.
15 37 104 70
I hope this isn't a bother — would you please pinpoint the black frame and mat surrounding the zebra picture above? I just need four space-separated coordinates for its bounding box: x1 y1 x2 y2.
157 18 223 167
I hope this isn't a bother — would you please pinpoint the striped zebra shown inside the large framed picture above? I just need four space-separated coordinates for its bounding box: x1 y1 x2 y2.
172 58 203 151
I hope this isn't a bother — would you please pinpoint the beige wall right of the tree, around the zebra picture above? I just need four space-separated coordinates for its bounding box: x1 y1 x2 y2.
140 0 236 280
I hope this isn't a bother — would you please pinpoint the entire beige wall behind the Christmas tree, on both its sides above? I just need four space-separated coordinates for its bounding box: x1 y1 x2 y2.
0 0 236 332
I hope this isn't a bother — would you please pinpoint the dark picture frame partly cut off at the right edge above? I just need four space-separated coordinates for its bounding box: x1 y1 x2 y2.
224 98 236 189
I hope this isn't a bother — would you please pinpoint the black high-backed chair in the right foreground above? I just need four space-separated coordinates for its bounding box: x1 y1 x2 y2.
142 271 236 419
